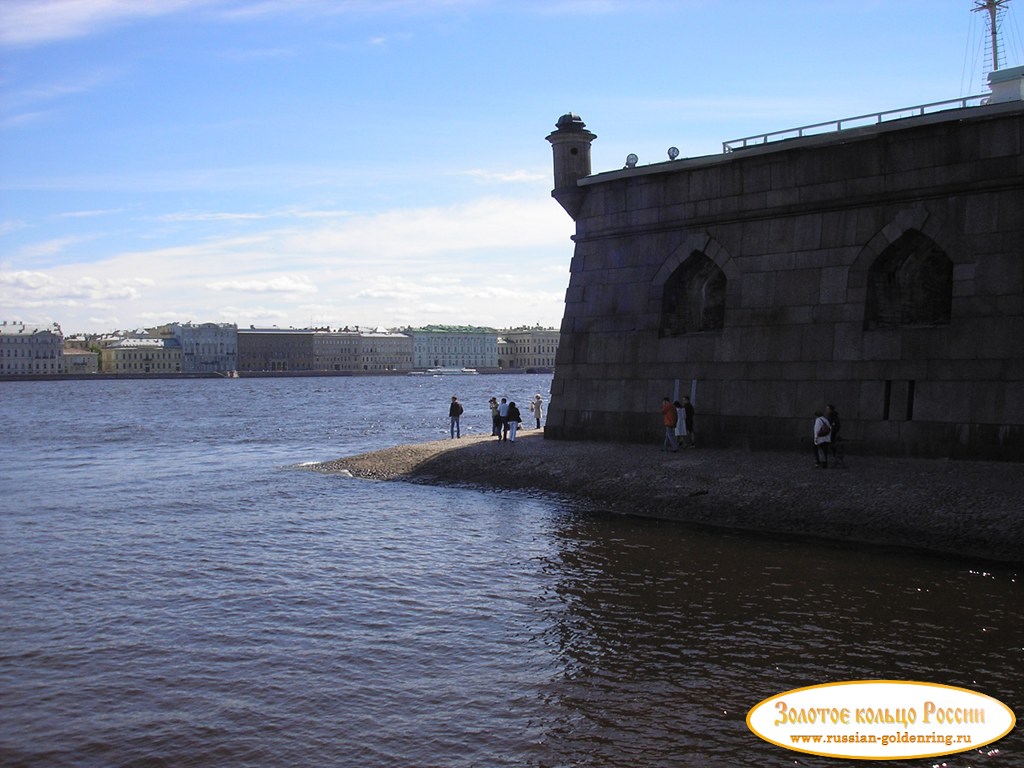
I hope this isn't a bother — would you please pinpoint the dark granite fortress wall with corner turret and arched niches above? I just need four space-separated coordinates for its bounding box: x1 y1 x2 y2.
546 101 1024 461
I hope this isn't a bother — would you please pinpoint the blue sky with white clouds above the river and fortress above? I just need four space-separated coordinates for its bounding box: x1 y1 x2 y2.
0 0 1024 335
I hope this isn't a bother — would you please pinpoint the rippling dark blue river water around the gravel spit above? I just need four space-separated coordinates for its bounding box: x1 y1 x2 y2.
0 375 1024 768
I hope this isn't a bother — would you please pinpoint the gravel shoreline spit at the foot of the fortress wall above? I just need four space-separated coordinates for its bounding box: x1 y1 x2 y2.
310 430 1024 563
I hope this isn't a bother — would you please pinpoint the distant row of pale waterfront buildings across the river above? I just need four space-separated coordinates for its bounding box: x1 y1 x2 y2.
0 321 559 377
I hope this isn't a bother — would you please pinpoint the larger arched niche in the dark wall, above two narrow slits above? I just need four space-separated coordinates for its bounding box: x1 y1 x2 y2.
864 229 953 329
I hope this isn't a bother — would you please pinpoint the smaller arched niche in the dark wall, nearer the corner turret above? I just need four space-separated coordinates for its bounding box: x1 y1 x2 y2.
660 251 726 337
